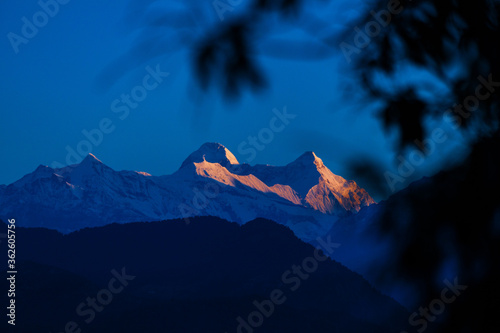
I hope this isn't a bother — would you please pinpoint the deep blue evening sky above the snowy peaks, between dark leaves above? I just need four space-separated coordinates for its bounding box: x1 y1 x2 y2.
0 0 462 199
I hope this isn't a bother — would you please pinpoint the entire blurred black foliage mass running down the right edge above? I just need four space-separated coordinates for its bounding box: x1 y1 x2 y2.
342 0 500 332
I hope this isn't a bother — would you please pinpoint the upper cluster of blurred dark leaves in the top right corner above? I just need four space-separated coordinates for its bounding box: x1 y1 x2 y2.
346 0 500 144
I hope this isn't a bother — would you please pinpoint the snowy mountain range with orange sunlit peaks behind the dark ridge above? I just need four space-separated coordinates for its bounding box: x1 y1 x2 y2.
0 143 374 237
